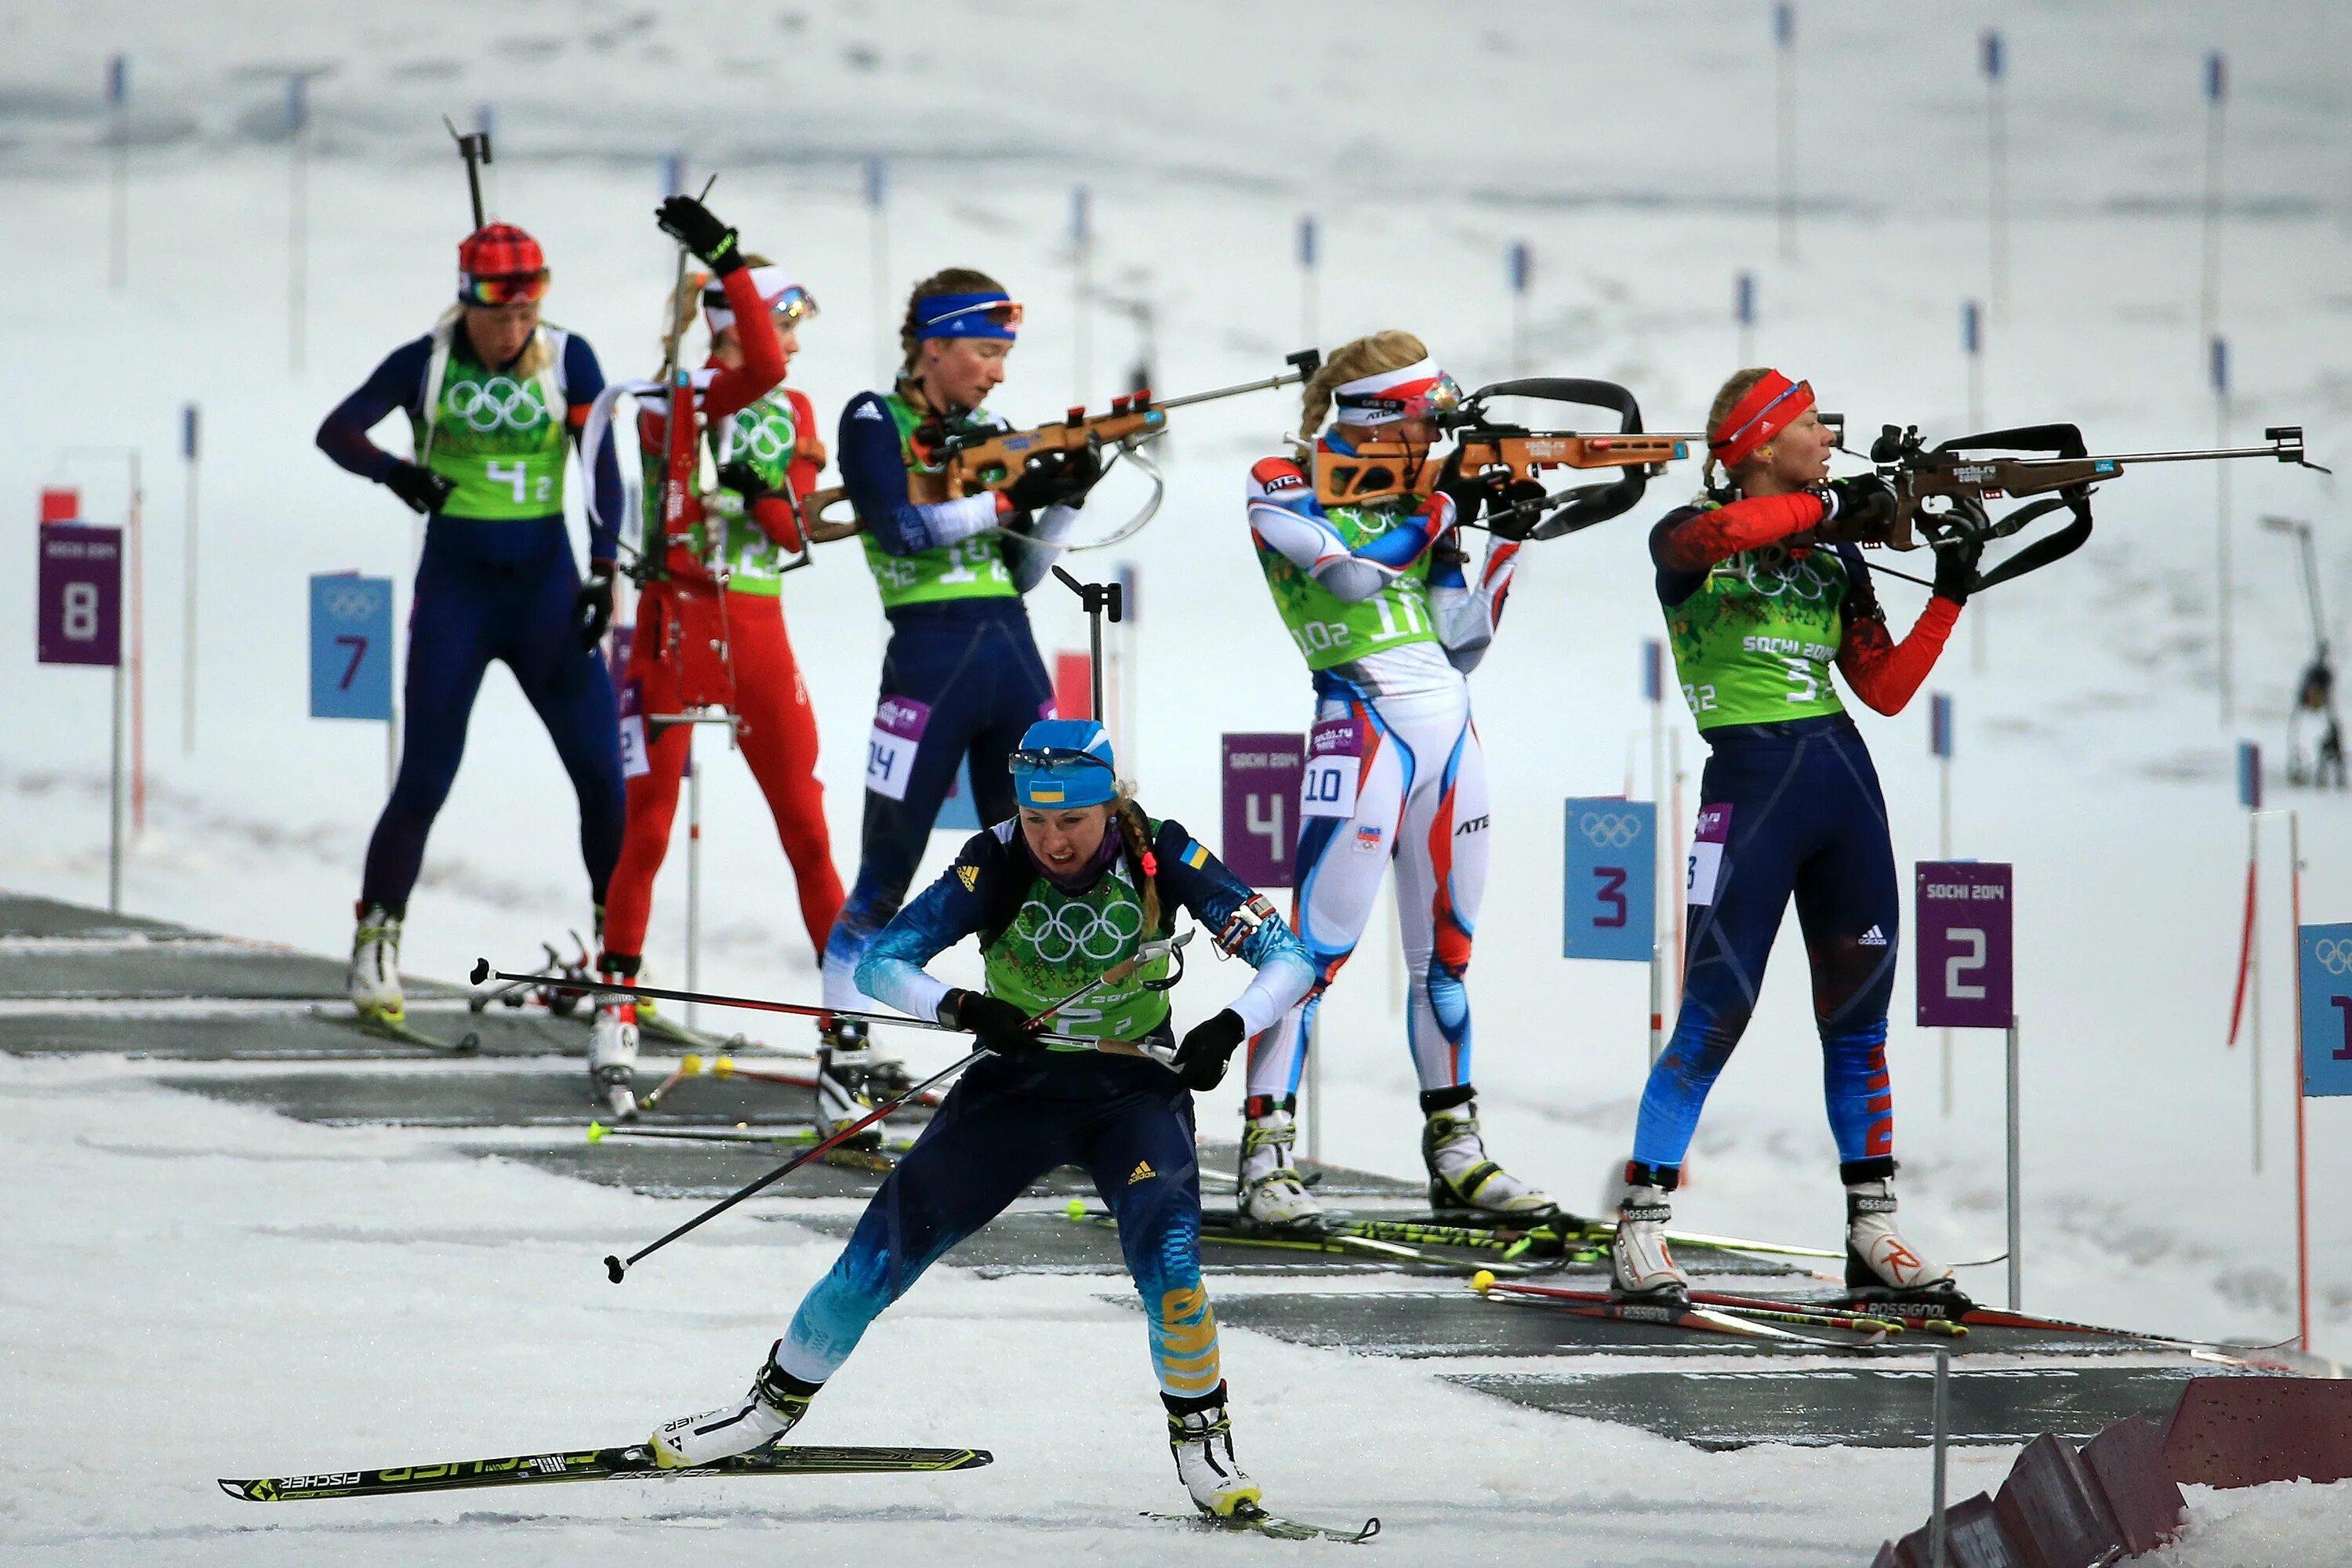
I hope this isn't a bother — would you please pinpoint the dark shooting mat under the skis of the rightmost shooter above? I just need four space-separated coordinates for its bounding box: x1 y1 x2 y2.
1216 1288 2154 1359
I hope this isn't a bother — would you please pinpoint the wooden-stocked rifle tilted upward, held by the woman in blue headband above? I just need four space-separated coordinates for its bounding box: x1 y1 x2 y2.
802 348 1322 550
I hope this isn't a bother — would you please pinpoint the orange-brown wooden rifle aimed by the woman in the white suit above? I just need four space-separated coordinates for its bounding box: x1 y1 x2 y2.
1315 376 1708 539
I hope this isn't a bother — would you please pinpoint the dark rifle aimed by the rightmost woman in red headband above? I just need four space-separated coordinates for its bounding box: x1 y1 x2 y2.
1823 414 2328 588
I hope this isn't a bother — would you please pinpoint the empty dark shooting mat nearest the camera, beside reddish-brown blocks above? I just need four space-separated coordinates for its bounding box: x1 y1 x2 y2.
1449 1363 2258 1448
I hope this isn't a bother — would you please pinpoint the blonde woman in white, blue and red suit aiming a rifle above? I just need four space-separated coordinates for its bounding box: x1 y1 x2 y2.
1237 332 1552 1225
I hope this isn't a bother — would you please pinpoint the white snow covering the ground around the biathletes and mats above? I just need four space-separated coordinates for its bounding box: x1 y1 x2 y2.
0 0 2352 1563
